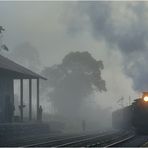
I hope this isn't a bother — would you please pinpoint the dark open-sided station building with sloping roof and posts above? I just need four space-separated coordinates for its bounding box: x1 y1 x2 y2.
0 55 46 123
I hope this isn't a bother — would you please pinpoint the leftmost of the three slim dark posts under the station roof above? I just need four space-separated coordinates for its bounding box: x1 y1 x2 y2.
19 79 23 121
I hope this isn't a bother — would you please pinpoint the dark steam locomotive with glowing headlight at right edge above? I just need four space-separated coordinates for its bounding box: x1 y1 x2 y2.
112 92 148 134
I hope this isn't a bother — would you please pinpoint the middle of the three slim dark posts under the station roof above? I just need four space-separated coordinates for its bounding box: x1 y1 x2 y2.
29 79 32 121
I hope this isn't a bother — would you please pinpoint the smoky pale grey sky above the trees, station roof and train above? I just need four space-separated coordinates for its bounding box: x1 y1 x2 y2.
0 1 148 108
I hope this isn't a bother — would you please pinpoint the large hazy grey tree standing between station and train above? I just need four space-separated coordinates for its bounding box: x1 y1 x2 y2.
42 52 106 116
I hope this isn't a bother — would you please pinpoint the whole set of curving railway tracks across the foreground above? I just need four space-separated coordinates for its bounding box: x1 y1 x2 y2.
0 130 133 147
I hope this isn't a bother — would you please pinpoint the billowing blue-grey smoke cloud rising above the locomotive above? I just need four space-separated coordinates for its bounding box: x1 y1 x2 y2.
65 2 148 91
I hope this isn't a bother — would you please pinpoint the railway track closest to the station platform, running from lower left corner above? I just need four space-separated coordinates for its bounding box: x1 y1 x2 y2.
0 131 109 147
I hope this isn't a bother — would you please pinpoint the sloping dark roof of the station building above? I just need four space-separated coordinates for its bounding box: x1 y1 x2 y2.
0 55 47 80
